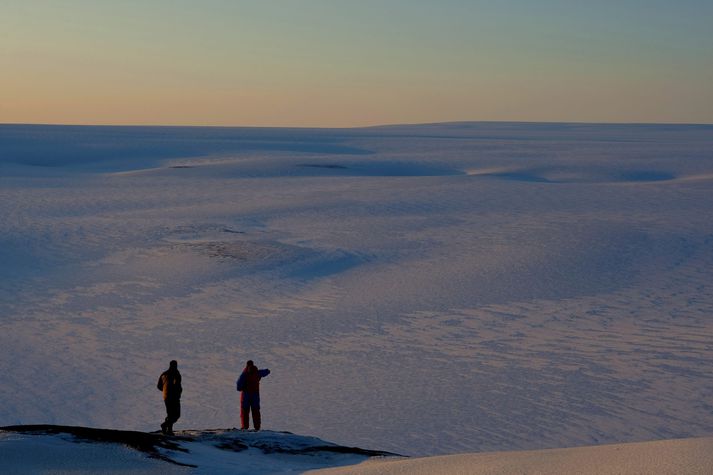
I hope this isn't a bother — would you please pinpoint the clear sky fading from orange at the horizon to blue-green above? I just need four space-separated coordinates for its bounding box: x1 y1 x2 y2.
0 0 713 127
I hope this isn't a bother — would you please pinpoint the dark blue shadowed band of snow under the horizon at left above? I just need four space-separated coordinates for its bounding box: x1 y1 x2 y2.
0 124 373 172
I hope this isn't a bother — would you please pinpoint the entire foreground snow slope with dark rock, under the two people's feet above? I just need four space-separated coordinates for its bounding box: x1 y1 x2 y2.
0 426 713 475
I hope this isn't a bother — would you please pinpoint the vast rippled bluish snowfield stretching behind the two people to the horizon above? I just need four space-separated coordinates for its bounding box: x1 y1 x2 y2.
0 123 713 455
